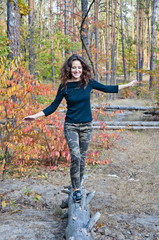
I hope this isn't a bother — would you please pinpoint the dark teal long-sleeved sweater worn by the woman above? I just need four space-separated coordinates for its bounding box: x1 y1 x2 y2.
43 79 118 123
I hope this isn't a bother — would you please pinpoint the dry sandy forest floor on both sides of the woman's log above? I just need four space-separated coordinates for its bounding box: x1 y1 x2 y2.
0 100 159 240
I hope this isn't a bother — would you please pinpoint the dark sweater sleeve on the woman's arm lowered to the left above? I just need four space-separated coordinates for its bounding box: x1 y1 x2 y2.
43 84 64 116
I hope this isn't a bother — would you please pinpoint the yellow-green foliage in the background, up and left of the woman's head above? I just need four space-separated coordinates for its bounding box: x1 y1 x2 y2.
35 31 80 80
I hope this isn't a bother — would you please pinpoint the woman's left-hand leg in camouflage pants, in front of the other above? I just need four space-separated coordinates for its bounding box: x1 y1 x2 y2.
64 123 81 189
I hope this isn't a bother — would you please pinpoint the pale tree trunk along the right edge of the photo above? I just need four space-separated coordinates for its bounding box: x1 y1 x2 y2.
150 0 159 89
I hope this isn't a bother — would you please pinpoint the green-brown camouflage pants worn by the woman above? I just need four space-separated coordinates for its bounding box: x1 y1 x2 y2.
64 122 93 189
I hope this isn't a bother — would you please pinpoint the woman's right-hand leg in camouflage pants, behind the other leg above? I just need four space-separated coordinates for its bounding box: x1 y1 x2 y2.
79 123 93 182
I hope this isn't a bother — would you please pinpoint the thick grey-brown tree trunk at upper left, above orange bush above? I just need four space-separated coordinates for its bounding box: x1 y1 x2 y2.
7 0 20 59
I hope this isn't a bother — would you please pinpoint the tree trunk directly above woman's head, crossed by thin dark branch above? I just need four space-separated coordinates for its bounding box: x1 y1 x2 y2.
81 0 89 57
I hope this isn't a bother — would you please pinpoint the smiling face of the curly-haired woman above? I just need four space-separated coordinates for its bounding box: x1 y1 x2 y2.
71 60 83 81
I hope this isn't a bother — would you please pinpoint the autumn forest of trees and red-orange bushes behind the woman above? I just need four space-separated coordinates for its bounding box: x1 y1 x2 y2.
0 0 159 174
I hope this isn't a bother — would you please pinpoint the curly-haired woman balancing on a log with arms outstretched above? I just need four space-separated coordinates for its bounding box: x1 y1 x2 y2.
24 54 137 202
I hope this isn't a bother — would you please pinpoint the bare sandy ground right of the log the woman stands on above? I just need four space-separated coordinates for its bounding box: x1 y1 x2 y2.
87 131 159 240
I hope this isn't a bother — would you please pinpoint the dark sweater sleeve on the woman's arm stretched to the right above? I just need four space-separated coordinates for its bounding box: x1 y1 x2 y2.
91 80 118 93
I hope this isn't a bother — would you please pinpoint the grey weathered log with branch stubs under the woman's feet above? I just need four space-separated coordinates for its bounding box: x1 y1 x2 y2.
61 182 100 240
